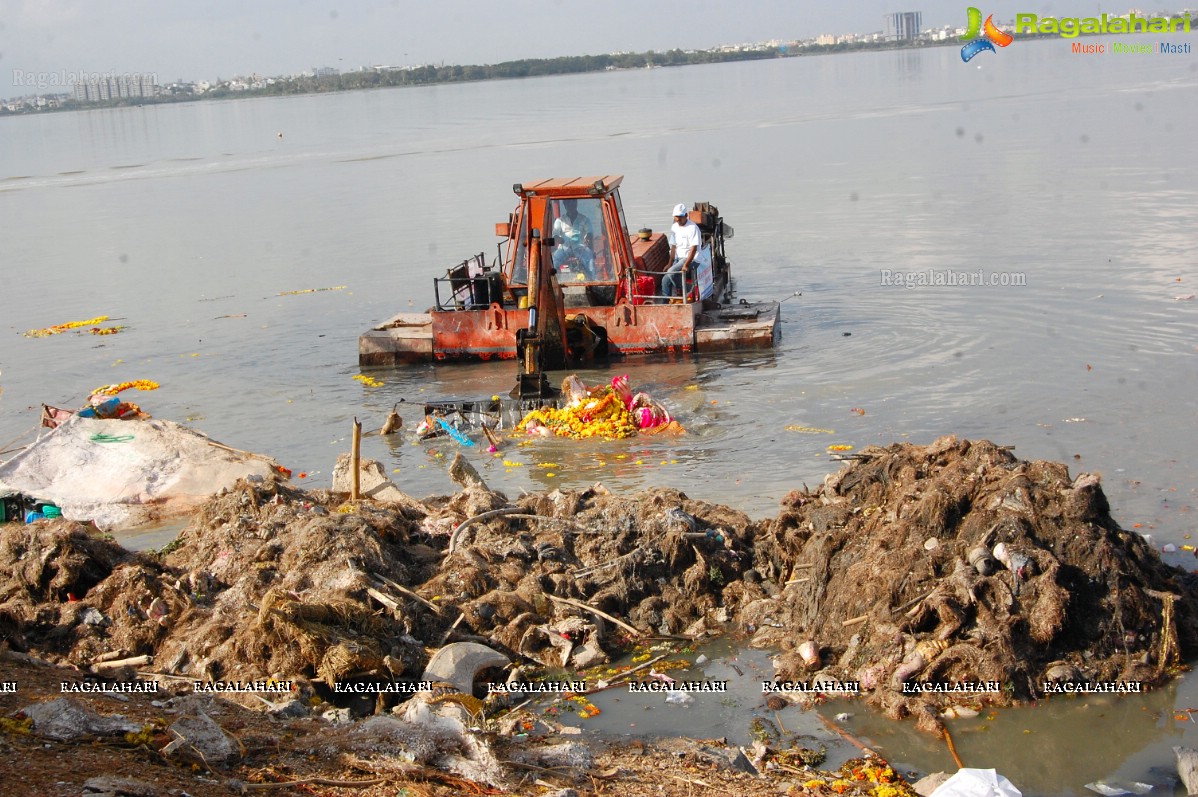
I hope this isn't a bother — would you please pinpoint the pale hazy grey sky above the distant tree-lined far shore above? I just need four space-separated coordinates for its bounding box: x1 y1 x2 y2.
0 0 1113 97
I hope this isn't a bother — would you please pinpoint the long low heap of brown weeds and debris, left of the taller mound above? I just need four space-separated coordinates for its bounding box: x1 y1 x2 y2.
0 457 764 686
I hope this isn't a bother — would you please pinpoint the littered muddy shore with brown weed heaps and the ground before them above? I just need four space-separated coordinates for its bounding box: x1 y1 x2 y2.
0 437 1198 793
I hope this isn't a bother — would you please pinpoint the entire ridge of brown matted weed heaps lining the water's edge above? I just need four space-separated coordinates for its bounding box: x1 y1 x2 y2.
0 437 1198 730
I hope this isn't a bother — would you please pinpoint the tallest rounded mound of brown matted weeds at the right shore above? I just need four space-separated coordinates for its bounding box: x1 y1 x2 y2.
739 437 1198 731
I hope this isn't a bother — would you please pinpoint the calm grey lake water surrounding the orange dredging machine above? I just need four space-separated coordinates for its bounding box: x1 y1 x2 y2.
0 40 1198 793
